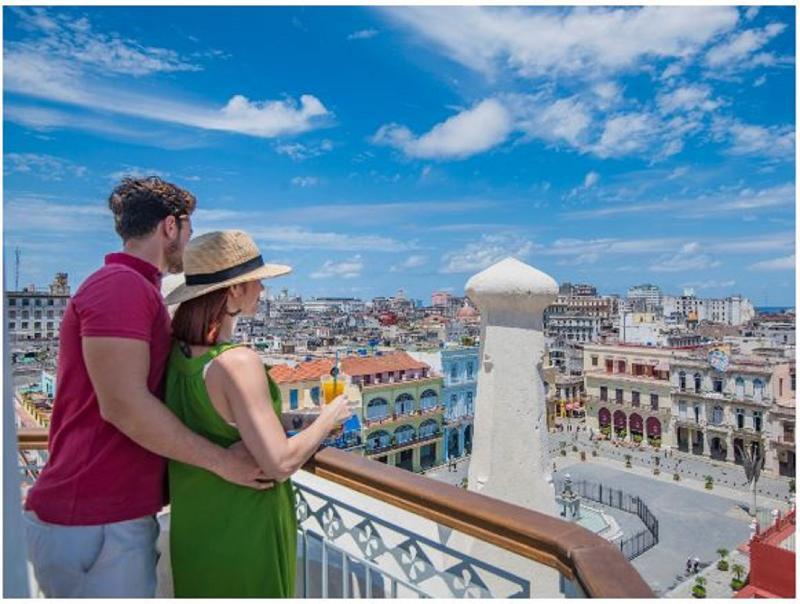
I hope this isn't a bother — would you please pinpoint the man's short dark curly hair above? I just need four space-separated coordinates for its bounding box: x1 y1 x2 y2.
108 176 197 241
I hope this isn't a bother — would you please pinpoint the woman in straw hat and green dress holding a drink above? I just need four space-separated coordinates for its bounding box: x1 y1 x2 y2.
165 231 351 598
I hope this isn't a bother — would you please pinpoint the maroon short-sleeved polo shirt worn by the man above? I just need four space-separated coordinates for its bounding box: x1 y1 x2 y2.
25 253 170 525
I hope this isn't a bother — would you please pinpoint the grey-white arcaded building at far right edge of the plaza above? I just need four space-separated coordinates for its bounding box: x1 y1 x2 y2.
670 347 795 475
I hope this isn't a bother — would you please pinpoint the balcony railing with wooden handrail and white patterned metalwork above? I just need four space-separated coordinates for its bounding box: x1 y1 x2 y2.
18 430 654 598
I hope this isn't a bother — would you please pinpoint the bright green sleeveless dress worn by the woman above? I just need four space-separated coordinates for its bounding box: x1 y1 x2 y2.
165 344 297 598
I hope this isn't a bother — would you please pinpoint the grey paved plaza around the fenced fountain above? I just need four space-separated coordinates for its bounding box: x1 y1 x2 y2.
426 433 788 597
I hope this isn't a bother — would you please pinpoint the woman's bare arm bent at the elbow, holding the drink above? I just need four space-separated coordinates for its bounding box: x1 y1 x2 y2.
208 347 351 481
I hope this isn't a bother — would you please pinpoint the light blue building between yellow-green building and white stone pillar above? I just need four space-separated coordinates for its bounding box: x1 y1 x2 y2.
409 345 478 460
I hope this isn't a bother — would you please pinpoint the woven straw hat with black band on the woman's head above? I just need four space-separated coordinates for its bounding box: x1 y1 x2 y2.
164 231 292 305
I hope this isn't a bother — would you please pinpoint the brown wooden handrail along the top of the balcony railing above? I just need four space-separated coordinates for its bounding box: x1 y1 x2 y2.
18 430 655 598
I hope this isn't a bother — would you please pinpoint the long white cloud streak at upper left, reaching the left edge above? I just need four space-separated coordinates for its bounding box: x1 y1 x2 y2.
3 14 332 138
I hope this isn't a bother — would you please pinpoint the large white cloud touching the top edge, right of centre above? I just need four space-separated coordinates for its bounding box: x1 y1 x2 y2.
384 6 738 80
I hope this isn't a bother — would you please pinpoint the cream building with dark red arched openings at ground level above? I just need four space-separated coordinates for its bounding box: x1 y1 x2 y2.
583 344 674 445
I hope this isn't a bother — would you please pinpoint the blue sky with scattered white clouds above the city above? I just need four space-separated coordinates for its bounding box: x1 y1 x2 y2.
3 6 795 305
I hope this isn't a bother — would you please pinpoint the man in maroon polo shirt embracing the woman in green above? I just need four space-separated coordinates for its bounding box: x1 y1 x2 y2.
25 177 270 598
